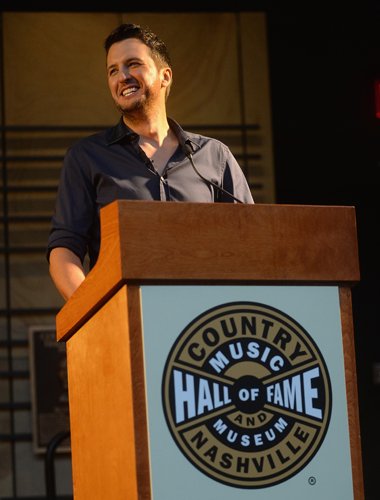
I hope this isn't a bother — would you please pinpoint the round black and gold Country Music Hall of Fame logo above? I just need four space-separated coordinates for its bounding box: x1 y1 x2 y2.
162 302 332 488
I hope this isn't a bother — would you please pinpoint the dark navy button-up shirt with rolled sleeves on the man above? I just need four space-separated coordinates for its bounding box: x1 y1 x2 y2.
48 118 253 267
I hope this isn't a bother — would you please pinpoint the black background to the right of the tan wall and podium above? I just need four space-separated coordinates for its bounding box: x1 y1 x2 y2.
267 1 380 500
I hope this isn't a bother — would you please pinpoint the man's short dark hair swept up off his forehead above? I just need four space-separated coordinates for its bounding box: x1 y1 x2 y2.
104 24 172 69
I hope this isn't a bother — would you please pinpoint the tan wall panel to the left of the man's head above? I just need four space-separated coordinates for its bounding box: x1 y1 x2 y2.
3 12 120 125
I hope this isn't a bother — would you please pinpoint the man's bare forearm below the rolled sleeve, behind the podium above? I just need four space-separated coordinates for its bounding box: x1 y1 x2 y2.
49 247 86 300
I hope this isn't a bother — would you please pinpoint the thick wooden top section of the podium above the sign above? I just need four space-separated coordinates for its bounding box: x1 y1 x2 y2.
57 201 360 340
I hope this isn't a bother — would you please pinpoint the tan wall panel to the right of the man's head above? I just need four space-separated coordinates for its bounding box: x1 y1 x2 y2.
123 13 240 125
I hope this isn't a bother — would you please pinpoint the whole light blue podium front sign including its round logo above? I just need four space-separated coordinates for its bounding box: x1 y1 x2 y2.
140 286 354 500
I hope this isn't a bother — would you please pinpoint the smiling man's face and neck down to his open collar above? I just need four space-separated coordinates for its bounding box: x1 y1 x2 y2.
107 38 179 172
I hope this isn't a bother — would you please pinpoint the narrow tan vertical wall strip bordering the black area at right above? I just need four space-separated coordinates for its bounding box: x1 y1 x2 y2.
239 12 275 203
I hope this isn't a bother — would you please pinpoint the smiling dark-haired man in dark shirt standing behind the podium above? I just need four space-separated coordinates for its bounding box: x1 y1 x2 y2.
48 24 253 300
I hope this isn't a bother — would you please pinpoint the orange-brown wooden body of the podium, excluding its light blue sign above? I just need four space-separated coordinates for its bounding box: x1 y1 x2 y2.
57 201 364 500
